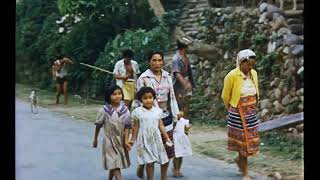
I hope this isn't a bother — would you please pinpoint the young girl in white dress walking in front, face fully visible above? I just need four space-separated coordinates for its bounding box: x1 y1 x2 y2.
129 87 172 180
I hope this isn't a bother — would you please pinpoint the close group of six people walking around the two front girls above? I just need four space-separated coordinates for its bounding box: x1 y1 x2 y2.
93 41 193 180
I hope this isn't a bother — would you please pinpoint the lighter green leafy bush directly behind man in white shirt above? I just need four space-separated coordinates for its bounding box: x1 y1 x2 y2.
93 20 174 94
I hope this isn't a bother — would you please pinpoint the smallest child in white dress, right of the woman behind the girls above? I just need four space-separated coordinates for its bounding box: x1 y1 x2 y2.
173 111 192 177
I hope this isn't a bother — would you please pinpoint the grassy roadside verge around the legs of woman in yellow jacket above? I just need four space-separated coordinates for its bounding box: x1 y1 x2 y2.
189 125 304 180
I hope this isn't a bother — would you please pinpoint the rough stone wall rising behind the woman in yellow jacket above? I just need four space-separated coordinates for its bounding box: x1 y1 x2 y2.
162 0 304 126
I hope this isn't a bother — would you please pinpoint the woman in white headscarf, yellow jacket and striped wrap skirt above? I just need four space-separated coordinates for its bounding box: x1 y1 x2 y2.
221 49 260 179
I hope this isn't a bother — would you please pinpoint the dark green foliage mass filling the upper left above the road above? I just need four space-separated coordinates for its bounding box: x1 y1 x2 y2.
16 0 159 96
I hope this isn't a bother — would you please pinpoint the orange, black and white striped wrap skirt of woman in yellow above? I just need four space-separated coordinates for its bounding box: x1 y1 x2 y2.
227 96 260 156
